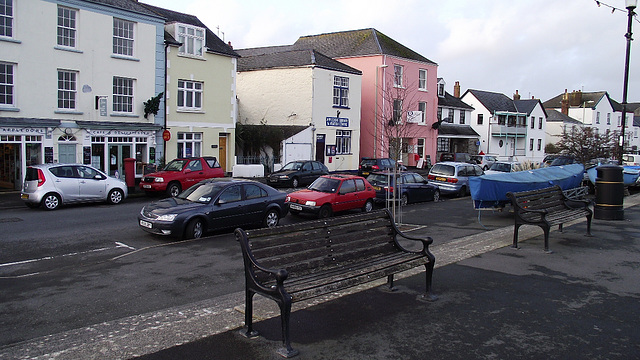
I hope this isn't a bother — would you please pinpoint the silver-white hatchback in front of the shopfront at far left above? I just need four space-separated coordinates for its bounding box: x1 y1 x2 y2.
20 164 128 210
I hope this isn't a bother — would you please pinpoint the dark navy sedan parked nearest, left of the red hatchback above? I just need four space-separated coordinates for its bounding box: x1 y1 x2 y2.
138 178 288 239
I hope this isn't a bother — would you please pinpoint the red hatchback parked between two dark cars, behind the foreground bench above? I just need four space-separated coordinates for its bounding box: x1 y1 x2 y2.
285 175 376 218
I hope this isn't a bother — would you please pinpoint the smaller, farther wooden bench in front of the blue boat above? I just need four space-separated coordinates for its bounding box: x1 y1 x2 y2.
507 185 593 252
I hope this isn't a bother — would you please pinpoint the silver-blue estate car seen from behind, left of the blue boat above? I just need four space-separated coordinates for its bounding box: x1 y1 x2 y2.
427 162 484 196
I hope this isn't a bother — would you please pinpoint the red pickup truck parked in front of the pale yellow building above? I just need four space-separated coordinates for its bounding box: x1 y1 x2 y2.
140 156 224 196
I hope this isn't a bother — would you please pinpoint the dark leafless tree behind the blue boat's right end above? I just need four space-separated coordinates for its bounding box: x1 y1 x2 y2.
556 126 616 164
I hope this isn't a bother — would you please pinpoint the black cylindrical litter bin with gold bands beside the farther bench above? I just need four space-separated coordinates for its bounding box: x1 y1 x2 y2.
593 165 624 220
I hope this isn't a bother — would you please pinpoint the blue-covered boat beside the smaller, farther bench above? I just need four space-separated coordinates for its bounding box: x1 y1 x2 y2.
469 164 584 209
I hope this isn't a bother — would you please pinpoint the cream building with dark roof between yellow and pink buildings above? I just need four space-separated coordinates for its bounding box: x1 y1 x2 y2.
236 47 362 171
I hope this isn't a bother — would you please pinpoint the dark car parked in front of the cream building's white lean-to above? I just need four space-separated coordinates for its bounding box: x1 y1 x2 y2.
267 160 329 188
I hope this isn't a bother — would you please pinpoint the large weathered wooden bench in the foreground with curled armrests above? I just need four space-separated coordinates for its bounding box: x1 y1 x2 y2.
235 210 437 357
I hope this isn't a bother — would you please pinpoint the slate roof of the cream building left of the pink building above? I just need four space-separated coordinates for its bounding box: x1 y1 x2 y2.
238 47 362 75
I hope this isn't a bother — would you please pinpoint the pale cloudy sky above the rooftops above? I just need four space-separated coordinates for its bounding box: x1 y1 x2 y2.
145 0 640 103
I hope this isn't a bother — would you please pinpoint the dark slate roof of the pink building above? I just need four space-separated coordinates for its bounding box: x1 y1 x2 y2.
293 28 436 65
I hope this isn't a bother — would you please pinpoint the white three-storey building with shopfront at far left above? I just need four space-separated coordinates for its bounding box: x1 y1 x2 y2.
0 0 164 189
